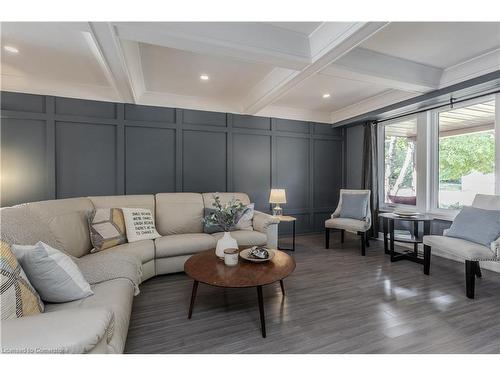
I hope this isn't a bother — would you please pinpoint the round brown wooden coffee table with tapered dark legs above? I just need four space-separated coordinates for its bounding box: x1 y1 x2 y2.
184 249 295 337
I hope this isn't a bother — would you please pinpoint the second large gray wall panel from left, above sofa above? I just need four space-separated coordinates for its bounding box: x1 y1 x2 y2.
56 122 118 198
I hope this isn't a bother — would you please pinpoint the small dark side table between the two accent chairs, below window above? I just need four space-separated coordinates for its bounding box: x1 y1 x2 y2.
379 212 433 275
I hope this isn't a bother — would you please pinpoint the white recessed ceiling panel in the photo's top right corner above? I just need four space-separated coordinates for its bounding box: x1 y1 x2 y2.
363 22 500 68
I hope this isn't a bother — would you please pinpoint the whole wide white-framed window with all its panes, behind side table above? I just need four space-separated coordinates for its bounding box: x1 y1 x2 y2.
378 94 500 219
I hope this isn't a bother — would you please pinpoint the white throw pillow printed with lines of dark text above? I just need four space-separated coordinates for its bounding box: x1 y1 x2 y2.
122 207 161 242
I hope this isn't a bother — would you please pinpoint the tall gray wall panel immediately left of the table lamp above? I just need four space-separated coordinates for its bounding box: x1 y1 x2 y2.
232 134 271 211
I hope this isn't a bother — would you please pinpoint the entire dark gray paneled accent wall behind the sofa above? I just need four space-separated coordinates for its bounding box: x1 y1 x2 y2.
1 92 345 234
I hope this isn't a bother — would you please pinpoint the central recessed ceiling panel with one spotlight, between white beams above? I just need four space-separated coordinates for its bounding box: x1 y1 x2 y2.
140 43 272 102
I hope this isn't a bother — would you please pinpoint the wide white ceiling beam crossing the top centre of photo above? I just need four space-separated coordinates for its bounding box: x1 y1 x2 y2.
114 22 310 69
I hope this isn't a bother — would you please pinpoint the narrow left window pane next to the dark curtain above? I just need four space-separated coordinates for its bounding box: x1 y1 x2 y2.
383 117 417 206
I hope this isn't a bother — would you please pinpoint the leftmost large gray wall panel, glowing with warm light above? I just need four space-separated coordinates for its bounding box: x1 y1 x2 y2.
0 119 47 206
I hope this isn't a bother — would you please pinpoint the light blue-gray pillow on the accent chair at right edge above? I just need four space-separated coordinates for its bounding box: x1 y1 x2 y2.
446 206 500 247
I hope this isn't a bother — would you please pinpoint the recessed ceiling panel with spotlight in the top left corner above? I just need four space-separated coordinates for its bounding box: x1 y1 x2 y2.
1 22 109 86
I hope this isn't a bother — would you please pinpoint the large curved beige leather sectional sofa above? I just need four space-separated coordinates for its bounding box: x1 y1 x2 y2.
0 193 278 353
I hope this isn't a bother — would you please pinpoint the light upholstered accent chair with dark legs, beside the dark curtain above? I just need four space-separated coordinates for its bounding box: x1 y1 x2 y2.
325 189 372 255
